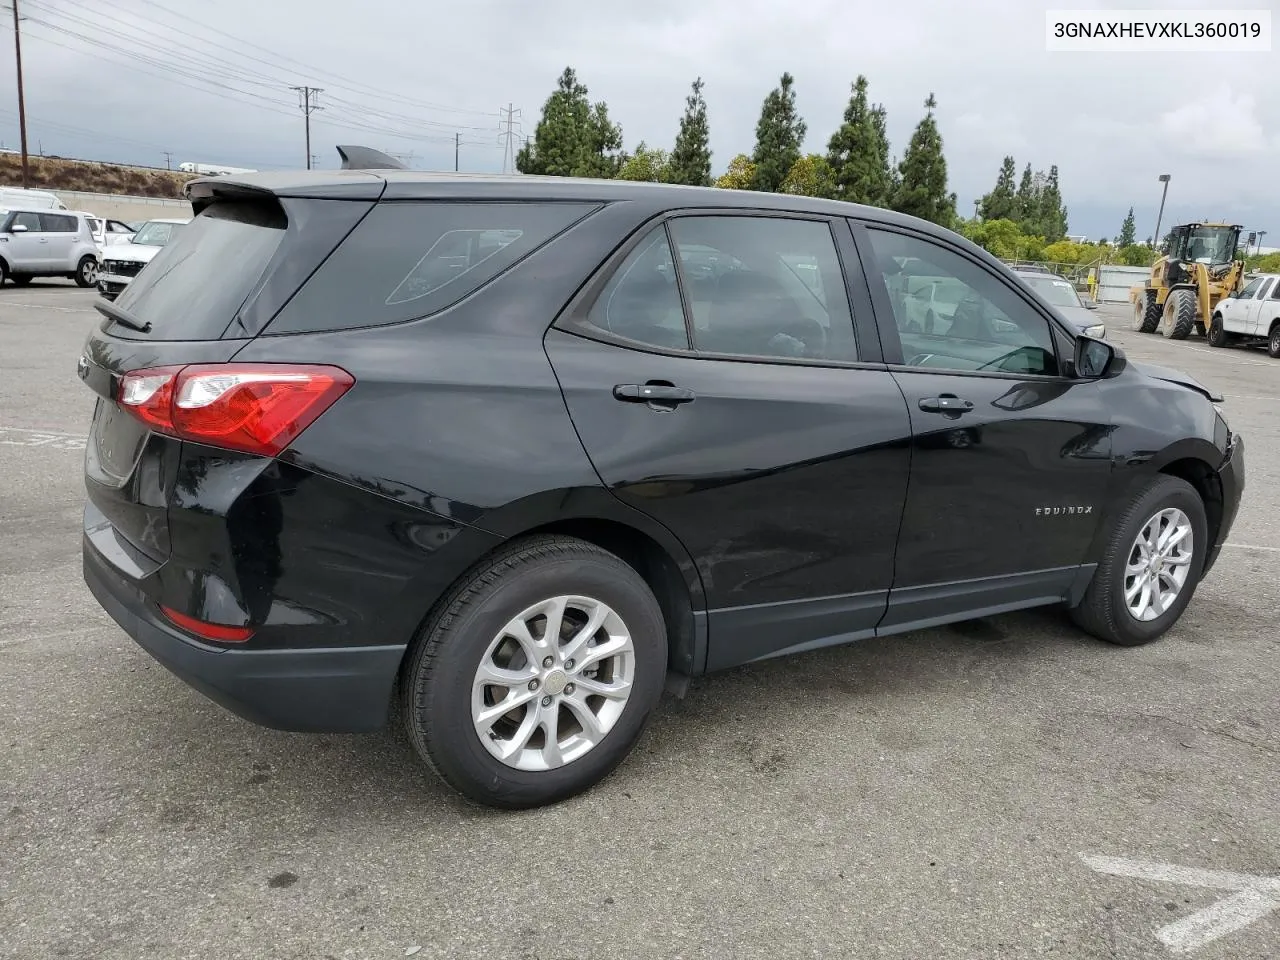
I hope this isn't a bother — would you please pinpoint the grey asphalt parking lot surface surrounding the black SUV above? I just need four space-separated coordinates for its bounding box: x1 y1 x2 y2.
0 283 1280 960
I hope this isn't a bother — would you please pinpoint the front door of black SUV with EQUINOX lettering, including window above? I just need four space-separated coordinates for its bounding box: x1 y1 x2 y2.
855 221 1111 628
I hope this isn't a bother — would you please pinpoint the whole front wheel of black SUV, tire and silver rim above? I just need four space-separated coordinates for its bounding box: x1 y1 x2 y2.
1071 475 1210 646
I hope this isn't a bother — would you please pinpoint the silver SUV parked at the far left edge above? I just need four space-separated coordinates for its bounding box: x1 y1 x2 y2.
0 209 99 287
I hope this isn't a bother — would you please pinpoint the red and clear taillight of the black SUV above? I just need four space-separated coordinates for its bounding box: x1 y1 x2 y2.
119 364 356 457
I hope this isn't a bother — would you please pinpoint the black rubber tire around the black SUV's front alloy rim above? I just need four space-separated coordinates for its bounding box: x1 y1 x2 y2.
1070 475 1210 646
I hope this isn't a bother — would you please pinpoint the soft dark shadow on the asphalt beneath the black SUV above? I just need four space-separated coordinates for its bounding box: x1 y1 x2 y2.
104 611 1114 836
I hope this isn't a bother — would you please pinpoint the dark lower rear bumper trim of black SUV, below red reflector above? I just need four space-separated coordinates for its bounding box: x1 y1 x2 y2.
83 536 406 733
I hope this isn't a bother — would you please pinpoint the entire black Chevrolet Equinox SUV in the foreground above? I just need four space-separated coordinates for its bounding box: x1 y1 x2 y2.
79 152 1244 808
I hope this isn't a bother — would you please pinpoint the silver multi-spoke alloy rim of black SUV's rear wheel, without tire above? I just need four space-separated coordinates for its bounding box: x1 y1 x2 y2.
471 596 636 771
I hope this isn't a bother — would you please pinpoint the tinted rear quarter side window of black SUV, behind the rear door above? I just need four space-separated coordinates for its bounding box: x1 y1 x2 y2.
266 201 598 334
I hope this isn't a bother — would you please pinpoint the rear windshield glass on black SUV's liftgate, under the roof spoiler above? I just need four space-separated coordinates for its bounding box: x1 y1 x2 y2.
116 201 287 340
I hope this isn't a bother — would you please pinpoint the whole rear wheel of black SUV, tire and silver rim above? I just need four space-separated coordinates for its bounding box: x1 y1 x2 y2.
401 536 667 809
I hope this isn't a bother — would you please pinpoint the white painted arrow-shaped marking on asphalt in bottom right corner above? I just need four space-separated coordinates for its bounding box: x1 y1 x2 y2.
1080 854 1280 954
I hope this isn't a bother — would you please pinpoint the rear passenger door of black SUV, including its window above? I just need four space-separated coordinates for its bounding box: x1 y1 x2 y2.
547 215 910 669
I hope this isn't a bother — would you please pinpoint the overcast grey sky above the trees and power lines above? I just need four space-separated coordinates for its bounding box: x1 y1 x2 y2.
0 0 1280 246
